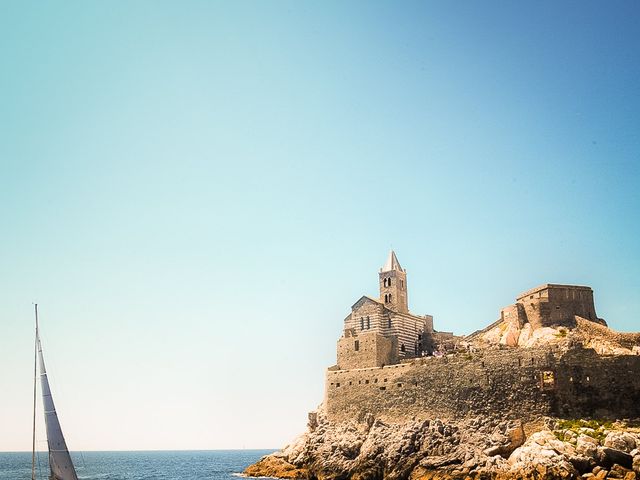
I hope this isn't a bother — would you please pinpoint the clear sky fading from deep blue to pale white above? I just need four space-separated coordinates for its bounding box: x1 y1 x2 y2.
0 0 640 451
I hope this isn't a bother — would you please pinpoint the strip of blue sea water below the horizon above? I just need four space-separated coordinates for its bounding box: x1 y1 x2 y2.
0 450 273 480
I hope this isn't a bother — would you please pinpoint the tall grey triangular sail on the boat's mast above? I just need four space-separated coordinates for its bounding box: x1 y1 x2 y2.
36 333 78 480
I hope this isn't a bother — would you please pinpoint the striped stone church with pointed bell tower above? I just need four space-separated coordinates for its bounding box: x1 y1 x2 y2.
337 251 433 370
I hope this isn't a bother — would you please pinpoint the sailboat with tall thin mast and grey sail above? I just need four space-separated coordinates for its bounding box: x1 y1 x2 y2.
31 304 78 480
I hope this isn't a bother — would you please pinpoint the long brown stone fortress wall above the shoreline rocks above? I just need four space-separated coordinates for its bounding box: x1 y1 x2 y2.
325 348 640 421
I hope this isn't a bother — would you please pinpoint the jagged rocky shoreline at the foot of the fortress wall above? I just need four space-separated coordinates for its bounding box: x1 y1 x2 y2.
245 410 640 480
